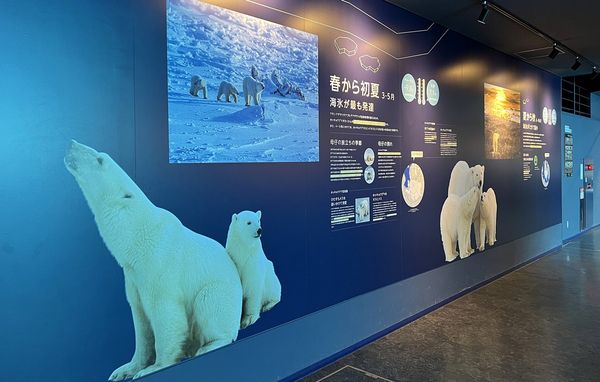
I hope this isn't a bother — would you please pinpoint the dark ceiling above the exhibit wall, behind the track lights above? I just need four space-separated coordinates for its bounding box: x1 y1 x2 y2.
388 0 600 84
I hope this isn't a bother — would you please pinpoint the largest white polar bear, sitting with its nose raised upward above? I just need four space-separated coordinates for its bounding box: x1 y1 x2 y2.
64 141 242 381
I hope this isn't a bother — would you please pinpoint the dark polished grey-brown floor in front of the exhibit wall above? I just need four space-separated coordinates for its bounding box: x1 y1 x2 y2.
301 229 600 382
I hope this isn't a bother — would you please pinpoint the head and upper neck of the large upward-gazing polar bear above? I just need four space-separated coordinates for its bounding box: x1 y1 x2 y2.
64 140 149 217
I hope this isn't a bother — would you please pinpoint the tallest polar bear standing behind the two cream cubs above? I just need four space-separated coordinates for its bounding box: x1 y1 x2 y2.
448 161 485 250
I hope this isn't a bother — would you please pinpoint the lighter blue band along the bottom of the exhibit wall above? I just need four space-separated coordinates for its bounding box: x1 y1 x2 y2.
144 224 562 382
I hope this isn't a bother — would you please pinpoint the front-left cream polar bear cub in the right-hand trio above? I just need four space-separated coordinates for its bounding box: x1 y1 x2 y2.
440 187 480 262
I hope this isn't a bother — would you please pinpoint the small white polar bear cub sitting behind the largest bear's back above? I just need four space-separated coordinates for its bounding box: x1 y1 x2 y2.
225 211 281 329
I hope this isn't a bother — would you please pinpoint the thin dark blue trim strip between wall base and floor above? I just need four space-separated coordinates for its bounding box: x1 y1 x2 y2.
280 243 564 382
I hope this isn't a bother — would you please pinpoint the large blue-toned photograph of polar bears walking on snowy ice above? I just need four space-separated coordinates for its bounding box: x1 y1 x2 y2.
167 0 319 163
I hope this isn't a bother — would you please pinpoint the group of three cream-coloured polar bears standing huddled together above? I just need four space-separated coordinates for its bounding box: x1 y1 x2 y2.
440 161 497 262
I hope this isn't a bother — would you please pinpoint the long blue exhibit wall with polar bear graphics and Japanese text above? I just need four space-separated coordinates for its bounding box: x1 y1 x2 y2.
0 0 564 381
